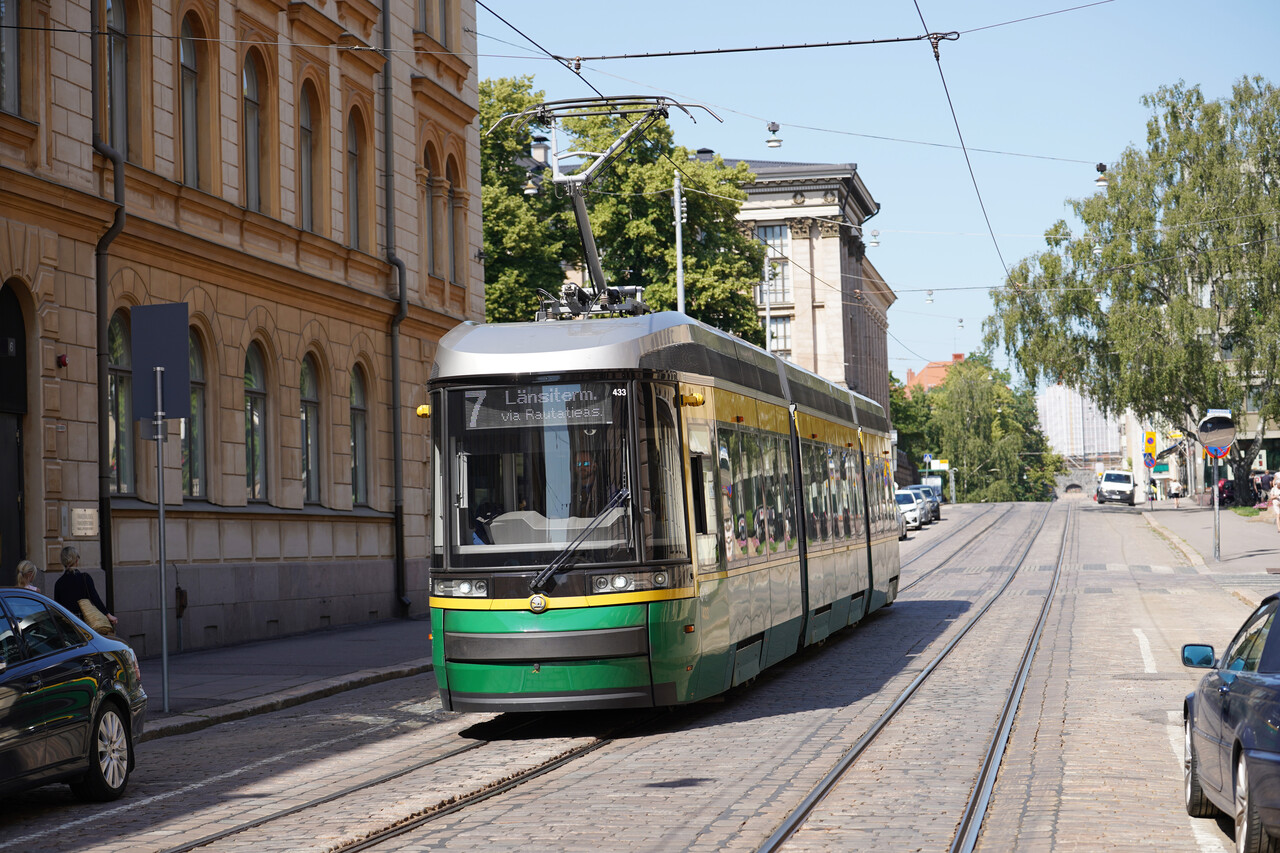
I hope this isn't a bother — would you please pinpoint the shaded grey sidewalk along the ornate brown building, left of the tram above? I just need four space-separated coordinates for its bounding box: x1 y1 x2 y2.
140 620 431 740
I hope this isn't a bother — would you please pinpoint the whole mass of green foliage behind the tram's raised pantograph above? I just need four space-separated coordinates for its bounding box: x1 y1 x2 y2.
480 78 764 345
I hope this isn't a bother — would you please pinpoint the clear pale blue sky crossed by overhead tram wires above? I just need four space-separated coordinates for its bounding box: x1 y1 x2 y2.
476 0 1280 379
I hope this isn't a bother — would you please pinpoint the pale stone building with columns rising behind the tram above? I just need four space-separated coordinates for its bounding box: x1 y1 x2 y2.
698 156 897 411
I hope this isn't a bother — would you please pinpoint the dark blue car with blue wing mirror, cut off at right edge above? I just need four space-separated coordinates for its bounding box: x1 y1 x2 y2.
1183 594 1280 853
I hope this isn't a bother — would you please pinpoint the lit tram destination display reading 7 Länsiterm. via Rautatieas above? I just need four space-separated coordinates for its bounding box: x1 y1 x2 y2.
466 384 614 429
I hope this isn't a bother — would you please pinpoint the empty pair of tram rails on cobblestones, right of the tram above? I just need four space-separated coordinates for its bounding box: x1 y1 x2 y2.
756 507 1076 853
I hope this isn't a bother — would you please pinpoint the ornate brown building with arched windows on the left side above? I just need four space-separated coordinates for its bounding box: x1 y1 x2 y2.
0 0 484 654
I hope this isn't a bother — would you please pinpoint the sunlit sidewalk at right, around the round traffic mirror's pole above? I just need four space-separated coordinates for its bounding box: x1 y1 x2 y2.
1142 498 1280 573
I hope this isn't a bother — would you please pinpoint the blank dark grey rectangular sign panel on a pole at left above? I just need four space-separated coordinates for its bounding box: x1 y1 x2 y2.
131 302 191 422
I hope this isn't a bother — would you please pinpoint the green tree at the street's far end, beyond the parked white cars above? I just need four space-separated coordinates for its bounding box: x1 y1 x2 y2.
926 355 1066 502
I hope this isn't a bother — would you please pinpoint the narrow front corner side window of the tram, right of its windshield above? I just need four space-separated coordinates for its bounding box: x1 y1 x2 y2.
640 383 689 560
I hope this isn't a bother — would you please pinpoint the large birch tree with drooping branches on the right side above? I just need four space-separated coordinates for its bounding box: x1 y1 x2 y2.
986 78 1280 502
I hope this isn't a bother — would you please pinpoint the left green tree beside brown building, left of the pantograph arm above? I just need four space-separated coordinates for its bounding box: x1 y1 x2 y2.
480 77 581 323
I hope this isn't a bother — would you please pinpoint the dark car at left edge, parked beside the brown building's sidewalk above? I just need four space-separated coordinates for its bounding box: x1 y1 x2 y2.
0 589 147 800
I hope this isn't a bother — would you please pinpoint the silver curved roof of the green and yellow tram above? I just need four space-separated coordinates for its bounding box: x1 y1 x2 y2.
431 311 888 432
